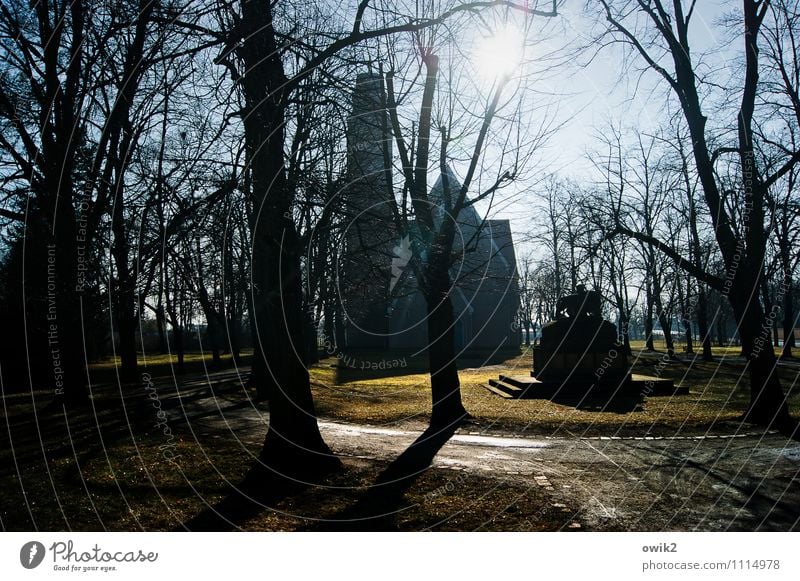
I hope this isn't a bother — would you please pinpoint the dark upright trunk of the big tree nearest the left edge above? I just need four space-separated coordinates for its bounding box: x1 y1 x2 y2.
31 2 88 404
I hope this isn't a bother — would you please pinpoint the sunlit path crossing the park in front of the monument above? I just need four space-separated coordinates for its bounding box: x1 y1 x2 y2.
159 370 800 531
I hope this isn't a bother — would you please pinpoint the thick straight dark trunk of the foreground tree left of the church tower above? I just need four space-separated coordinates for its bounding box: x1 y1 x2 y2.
239 0 340 479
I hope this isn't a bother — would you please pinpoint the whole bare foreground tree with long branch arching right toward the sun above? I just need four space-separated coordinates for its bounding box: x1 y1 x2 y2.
218 0 555 475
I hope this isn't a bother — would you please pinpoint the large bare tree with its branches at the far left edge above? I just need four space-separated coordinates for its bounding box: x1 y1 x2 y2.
0 0 100 401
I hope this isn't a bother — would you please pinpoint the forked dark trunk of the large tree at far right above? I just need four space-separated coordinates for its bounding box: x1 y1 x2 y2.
605 0 792 431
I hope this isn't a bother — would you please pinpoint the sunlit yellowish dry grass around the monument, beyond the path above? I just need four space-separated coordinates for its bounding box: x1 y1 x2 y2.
311 343 800 435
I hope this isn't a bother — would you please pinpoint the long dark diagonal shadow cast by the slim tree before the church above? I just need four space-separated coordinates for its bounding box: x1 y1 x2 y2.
311 422 460 531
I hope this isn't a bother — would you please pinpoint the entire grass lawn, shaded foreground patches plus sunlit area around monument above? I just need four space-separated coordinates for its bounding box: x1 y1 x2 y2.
0 345 800 530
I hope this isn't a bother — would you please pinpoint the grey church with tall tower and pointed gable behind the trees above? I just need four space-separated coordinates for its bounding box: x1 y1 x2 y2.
338 73 520 355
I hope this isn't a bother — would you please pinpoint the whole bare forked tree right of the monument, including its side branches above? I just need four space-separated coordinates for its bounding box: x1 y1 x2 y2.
598 0 800 430
